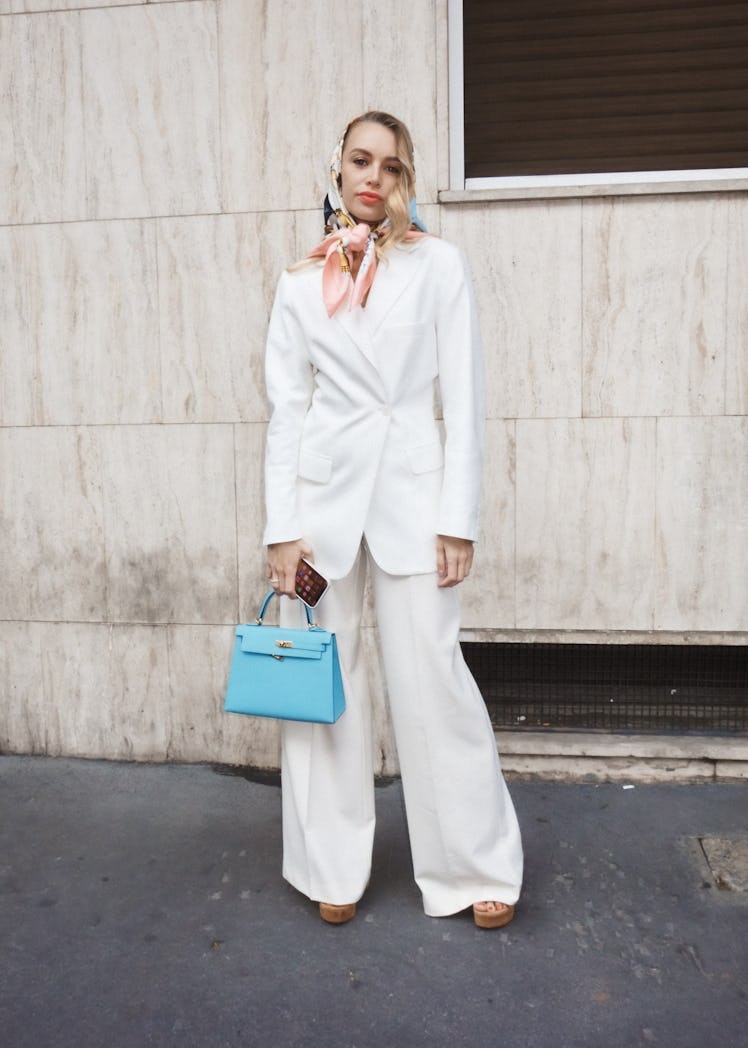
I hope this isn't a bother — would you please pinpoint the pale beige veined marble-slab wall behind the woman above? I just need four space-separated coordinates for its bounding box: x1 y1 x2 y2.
0 0 748 772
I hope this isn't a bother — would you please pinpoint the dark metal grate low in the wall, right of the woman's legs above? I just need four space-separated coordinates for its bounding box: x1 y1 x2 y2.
462 641 748 733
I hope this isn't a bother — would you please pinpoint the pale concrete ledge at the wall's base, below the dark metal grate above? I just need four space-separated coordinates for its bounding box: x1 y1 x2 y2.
496 732 748 783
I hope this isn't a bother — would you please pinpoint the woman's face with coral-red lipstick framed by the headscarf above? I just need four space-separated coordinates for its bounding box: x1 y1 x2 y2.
340 121 402 225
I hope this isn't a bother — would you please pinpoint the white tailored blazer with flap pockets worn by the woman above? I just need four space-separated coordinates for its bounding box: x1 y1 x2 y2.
264 237 484 578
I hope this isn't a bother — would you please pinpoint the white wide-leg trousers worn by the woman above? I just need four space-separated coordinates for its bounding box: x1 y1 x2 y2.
282 547 523 917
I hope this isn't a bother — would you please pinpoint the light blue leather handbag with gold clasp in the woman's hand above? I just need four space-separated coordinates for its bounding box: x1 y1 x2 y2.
224 590 346 724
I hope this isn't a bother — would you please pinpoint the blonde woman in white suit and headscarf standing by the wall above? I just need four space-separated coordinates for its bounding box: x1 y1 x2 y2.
264 112 522 927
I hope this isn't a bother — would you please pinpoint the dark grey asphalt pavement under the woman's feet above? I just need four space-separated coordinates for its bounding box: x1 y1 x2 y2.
0 756 748 1048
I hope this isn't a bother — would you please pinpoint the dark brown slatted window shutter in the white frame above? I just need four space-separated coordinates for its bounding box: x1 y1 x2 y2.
463 0 748 178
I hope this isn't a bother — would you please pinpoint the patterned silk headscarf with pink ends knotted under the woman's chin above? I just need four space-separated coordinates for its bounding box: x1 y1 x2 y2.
308 122 426 316
